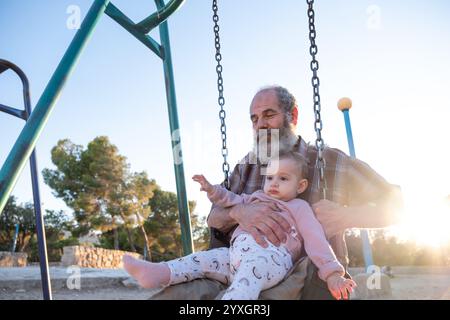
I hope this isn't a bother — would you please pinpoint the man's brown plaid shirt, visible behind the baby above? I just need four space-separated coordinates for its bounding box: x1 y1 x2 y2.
210 137 392 267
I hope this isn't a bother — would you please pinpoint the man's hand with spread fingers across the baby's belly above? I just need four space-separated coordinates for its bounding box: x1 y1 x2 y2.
230 202 291 248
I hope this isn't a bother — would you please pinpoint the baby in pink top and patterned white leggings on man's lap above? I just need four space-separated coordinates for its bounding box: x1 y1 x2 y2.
124 152 356 300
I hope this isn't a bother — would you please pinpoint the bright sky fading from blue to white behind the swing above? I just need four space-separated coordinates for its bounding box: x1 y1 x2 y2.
0 0 450 244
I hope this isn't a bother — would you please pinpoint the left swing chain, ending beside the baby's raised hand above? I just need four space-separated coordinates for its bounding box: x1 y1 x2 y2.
212 0 230 189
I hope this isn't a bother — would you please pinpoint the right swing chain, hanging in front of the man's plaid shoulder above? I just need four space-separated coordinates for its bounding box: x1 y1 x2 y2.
306 0 327 199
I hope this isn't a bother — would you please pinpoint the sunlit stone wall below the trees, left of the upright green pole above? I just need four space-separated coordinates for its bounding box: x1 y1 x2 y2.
61 246 142 269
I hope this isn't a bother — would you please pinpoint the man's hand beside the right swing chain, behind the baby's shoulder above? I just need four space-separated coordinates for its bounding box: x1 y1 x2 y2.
312 200 349 239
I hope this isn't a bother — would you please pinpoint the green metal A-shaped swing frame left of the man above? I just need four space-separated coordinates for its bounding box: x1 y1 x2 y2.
0 0 193 300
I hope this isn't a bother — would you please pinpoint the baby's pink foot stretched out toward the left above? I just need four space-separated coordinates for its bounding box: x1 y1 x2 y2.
123 255 170 289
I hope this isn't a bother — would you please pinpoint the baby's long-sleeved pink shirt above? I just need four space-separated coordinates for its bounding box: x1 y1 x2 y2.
208 185 345 281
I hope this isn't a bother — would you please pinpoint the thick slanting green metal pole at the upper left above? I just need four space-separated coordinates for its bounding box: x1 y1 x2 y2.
0 0 110 214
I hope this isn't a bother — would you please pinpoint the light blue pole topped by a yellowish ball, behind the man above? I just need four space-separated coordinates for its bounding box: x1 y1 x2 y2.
339 98 373 272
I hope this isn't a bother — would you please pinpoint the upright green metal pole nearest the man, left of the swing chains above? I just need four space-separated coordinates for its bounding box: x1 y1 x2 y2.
155 0 194 255
